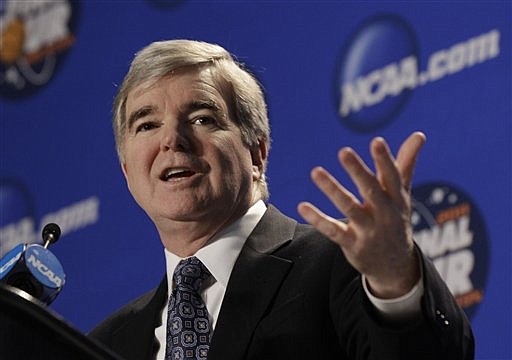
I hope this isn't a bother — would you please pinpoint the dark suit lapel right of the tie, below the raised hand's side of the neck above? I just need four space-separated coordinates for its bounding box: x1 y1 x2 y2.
208 206 296 360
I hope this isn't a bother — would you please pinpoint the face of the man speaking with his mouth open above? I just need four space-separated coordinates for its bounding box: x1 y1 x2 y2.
122 68 264 228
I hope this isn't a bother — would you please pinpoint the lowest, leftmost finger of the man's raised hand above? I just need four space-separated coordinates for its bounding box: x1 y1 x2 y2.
297 202 353 246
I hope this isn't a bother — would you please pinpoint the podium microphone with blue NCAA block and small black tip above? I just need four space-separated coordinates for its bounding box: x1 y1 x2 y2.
0 223 66 305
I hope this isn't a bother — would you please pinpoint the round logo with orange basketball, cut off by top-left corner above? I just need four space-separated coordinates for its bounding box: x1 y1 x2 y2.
0 0 78 99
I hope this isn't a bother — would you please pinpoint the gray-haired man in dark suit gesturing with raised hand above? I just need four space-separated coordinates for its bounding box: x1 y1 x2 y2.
91 40 474 360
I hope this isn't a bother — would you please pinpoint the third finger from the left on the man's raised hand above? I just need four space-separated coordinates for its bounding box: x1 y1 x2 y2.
338 148 387 208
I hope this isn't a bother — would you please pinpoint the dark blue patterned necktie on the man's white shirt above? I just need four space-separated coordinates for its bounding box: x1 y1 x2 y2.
165 257 211 360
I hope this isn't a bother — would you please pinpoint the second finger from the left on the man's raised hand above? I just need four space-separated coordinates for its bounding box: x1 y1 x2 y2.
311 167 367 223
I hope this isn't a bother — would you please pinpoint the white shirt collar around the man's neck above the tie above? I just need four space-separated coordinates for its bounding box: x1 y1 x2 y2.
164 200 267 294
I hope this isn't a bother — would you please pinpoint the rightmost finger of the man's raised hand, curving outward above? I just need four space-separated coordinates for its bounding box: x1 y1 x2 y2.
396 131 427 190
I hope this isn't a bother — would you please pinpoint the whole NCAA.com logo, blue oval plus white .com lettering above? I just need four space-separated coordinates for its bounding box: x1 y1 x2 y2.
334 15 501 132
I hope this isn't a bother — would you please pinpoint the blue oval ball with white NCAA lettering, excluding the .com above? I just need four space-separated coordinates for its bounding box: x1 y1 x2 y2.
334 14 418 132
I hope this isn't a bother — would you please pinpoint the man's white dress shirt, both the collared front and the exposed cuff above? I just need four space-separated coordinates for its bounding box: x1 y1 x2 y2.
155 200 423 360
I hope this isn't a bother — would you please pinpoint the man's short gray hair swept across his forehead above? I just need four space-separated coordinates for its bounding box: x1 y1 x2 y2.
112 40 270 200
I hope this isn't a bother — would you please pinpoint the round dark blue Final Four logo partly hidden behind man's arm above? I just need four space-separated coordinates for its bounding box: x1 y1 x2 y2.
412 183 489 317
